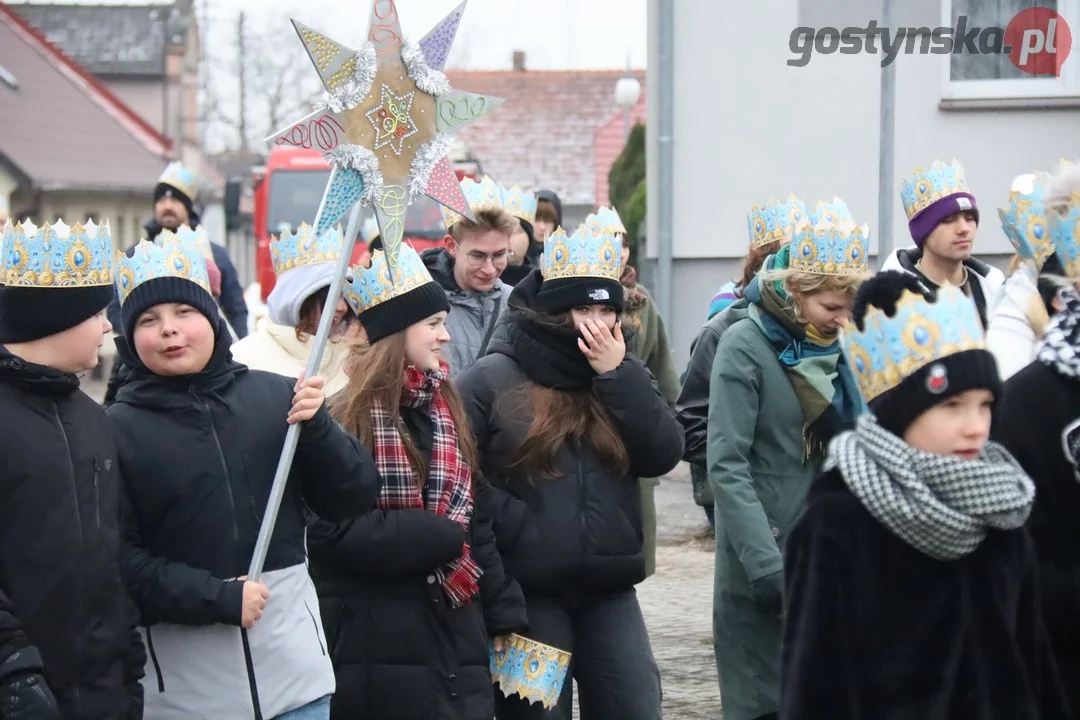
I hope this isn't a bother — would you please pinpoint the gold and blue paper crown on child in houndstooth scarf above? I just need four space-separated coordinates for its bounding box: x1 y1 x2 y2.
840 285 986 403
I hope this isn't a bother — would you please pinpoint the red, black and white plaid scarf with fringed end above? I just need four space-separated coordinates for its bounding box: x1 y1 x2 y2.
372 362 482 608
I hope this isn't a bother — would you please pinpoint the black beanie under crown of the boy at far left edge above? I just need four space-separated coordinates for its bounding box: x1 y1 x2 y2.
0 285 117 344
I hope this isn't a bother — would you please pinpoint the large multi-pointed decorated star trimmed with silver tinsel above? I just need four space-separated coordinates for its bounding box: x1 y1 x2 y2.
263 0 502 275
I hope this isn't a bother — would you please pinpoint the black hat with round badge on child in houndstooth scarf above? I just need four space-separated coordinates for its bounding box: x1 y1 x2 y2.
852 270 1001 437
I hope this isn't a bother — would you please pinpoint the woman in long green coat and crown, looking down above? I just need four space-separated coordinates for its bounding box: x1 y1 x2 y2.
706 201 868 720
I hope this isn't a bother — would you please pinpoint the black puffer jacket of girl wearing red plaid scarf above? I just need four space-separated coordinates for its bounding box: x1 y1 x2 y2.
308 408 526 720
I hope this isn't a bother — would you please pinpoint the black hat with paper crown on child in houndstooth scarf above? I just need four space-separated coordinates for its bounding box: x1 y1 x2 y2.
841 271 1001 436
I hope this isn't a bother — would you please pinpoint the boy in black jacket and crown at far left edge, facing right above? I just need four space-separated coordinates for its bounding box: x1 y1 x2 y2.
0 222 145 720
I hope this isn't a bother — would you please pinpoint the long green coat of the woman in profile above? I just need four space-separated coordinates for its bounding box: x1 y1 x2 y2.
706 317 819 720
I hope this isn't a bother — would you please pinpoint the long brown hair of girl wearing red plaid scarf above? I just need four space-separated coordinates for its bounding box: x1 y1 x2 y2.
329 330 480 484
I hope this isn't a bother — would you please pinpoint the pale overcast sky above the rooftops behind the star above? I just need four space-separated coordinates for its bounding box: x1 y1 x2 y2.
16 0 647 151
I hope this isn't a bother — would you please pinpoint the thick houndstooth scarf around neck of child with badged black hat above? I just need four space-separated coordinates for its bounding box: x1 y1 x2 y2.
825 413 1035 560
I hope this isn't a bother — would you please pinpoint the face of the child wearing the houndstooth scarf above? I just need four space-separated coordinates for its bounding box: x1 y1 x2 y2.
904 390 994 460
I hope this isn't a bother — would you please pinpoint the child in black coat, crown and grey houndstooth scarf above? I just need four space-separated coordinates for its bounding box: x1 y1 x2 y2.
780 271 1072 720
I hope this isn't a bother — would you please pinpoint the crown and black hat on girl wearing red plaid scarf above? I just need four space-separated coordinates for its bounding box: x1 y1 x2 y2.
345 244 450 343
